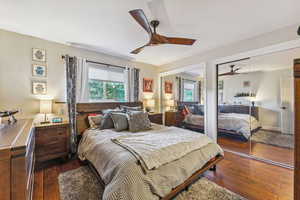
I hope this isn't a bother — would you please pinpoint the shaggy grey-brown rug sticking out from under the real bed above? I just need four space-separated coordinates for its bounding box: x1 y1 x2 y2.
58 166 245 200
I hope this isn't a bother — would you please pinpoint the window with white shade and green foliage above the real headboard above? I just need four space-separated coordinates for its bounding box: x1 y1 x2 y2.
89 64 126 102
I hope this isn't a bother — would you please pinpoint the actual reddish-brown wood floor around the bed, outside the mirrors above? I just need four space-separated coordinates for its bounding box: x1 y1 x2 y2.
33 153 293 200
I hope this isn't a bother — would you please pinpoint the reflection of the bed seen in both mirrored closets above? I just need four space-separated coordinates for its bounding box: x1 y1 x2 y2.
178 102 261 141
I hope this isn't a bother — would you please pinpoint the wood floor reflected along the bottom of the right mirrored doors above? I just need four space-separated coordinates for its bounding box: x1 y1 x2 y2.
218 137 294 166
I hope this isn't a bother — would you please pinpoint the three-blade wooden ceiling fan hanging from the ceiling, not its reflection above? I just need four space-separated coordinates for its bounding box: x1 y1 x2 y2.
129 9 196 54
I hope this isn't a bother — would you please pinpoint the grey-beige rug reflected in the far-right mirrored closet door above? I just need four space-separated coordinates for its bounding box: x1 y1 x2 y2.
251 130 294 149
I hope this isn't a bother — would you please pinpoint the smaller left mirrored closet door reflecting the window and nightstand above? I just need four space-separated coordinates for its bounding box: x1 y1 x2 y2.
161 67 205 133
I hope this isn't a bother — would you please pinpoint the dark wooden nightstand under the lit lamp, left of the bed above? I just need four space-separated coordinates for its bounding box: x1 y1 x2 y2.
35 122 70 163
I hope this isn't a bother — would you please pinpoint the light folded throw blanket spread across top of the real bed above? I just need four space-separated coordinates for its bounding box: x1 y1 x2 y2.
112 127 212 170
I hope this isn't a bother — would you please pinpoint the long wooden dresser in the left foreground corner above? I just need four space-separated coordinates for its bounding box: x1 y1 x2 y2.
0 120 35 200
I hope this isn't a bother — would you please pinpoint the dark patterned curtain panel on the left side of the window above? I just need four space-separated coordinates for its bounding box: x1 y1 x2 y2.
65 55 77 153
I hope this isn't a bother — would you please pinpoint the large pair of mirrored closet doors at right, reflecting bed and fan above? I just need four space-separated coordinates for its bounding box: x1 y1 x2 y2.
217 49 300 167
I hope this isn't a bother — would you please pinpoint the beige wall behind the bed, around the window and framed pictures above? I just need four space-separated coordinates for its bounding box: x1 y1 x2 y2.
0 29 158 117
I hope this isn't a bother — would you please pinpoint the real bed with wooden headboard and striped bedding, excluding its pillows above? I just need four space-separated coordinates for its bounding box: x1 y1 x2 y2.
77 102 223 200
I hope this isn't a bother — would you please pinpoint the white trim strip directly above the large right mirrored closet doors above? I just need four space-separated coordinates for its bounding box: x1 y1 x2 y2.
214 39 300 65
